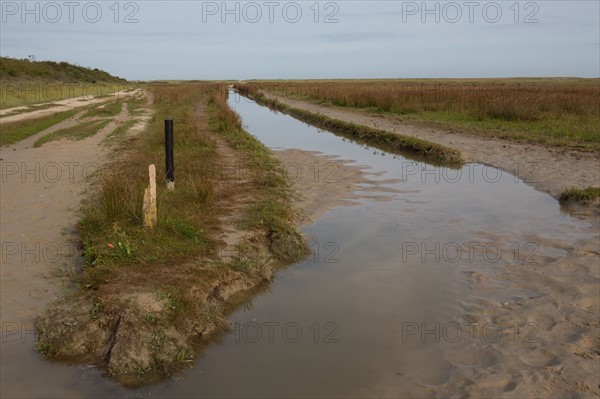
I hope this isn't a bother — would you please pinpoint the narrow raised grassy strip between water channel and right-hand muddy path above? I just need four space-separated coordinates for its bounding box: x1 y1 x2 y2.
235 84 463 167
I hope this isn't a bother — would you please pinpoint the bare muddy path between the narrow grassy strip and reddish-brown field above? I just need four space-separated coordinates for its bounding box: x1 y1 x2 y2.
265 93 600 198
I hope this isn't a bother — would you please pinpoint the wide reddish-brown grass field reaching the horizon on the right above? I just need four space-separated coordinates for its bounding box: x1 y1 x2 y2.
253 78 600 151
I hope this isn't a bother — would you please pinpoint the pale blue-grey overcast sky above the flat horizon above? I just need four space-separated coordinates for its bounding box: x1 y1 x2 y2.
0 0 600 80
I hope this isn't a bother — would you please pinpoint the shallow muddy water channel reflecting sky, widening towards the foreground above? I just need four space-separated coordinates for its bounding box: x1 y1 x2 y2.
3 93 589 397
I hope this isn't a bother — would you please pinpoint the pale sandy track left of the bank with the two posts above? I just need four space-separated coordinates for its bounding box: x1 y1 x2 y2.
0 99 141 323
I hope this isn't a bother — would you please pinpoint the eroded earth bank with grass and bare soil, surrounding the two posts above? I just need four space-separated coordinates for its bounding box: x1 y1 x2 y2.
36 85 306 384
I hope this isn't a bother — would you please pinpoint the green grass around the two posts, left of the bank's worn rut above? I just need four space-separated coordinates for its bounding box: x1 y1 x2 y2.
75 87 213 278
